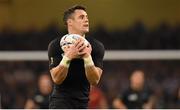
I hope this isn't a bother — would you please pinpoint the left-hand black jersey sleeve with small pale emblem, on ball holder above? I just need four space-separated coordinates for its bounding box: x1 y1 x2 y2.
48 40 62 70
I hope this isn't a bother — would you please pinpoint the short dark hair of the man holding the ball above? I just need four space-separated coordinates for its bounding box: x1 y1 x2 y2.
63 5 86 25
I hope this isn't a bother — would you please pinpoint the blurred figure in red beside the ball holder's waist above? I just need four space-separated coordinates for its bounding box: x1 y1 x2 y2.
88 86 108 109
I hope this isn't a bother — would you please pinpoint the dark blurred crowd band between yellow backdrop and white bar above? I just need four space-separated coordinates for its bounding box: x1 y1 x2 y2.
0 22 180 50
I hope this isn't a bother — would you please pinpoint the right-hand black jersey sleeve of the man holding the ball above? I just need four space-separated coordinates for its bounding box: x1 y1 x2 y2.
92 42 105 69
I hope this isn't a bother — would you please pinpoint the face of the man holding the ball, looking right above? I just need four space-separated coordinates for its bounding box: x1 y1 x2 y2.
69 10 89 34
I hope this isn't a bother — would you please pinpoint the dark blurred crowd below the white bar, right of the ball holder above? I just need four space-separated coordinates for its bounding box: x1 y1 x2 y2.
99 60 180 109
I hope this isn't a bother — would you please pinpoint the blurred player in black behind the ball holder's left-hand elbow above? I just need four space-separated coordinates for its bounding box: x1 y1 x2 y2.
25 74 52 109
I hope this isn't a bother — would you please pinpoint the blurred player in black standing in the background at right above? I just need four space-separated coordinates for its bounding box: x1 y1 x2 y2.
113 70 155 109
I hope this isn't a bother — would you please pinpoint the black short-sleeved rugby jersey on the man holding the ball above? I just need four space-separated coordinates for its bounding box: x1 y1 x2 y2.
48 37 104 101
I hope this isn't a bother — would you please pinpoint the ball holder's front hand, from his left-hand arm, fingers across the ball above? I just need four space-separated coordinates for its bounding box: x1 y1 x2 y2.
64 39 86 60
